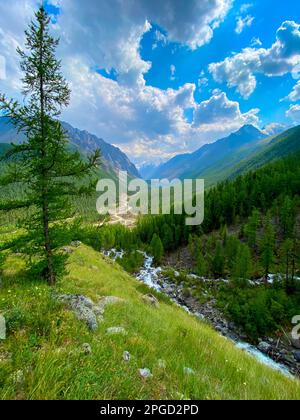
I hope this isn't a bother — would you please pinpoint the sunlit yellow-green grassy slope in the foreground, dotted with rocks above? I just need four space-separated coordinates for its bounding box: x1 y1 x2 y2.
0 245 300 399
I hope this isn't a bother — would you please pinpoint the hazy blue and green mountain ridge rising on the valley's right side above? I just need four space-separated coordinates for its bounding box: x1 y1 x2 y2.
149 125 300 187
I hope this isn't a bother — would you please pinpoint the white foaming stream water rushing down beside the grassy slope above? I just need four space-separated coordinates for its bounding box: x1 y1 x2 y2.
104 249 292 377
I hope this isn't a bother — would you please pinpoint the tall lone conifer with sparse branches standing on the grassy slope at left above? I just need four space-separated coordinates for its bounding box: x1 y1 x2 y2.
0 7 100 285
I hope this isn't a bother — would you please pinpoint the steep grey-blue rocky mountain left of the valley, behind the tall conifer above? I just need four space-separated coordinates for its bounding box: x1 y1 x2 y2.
0 117 139 177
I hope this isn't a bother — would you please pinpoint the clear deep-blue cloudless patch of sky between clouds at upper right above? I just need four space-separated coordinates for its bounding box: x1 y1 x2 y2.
141 0 300 125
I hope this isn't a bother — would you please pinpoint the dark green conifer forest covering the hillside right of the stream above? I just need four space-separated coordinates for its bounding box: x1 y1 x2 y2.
78 151 300 339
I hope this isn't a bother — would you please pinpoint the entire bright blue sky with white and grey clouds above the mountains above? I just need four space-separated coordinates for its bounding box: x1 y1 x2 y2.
0 0 300 165
